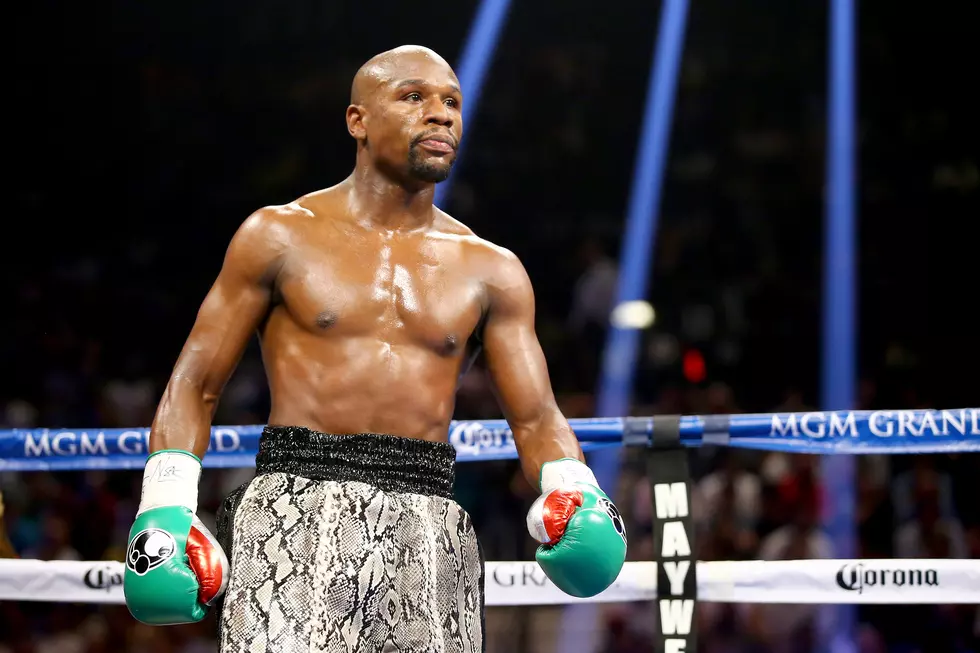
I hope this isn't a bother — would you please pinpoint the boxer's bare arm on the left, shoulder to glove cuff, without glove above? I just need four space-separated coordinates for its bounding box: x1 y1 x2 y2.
150 208 285 458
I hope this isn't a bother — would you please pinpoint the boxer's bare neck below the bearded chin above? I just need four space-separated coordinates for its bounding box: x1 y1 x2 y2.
350 162 435 230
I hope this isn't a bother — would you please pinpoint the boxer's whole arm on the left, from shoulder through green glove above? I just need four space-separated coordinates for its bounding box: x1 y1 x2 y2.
123 209 288 625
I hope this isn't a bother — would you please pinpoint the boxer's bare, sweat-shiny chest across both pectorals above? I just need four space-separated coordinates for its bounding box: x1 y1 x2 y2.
279 238 484 354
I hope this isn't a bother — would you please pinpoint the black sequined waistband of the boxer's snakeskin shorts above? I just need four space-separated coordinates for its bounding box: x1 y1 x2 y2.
255 426 456 499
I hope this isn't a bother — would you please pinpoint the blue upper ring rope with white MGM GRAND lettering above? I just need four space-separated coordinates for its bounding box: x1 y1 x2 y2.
0 408 980 471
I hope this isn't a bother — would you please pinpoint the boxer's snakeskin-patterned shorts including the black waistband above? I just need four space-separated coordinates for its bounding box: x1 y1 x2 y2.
218 427 484 653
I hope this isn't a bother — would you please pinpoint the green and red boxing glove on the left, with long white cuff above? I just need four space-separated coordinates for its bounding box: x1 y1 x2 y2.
123 450 229 626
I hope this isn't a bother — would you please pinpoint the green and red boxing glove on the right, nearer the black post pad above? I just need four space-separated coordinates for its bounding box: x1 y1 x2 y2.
527 458 626 598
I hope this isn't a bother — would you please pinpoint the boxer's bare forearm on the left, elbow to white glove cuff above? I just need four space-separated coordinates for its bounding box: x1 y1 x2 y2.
150 375 217 458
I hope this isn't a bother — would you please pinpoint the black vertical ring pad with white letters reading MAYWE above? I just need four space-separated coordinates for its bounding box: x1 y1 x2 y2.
647 415 698 653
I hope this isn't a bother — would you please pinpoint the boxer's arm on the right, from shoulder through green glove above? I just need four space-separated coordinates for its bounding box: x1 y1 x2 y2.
483 253 626 597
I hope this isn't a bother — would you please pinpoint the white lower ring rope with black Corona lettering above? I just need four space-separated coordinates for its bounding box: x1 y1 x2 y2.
0 559 980 612
